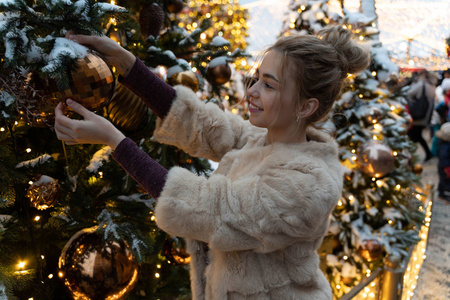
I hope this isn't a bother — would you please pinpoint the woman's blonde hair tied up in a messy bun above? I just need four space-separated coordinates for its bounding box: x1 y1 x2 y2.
266 26 370 125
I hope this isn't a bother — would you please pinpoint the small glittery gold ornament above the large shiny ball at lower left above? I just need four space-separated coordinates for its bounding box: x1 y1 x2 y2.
25 175 61 210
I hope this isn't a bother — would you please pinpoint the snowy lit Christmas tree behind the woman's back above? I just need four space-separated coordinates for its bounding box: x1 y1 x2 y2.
282 0 424 298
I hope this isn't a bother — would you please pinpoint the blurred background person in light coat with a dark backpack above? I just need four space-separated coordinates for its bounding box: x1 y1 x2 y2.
407 70 437 161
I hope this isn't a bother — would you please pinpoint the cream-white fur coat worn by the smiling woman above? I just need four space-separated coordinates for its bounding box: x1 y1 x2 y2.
154 86 342 300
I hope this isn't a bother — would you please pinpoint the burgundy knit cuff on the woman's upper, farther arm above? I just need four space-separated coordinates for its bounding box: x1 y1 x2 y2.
118 57 176 119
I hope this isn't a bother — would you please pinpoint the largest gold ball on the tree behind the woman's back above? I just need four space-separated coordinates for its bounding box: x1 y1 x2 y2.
357 141 395 178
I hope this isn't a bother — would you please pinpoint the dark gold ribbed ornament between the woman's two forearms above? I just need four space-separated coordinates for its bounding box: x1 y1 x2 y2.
104 83 150 132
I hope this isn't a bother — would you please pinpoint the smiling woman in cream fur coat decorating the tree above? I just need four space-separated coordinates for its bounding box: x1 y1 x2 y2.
55 27 369 300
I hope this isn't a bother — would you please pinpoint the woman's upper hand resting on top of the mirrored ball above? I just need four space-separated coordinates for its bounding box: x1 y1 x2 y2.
66 31 136 77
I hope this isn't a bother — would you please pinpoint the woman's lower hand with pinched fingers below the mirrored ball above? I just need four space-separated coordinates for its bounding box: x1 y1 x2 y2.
55 99 125 149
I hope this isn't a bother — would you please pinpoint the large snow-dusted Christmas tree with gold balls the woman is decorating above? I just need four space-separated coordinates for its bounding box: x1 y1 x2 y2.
0 0 247 300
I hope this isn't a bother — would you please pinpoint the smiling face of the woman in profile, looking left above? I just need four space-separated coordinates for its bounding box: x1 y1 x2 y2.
247 51 297 134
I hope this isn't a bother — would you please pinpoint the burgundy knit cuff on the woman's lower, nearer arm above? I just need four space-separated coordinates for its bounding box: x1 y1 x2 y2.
112 138 168 199
